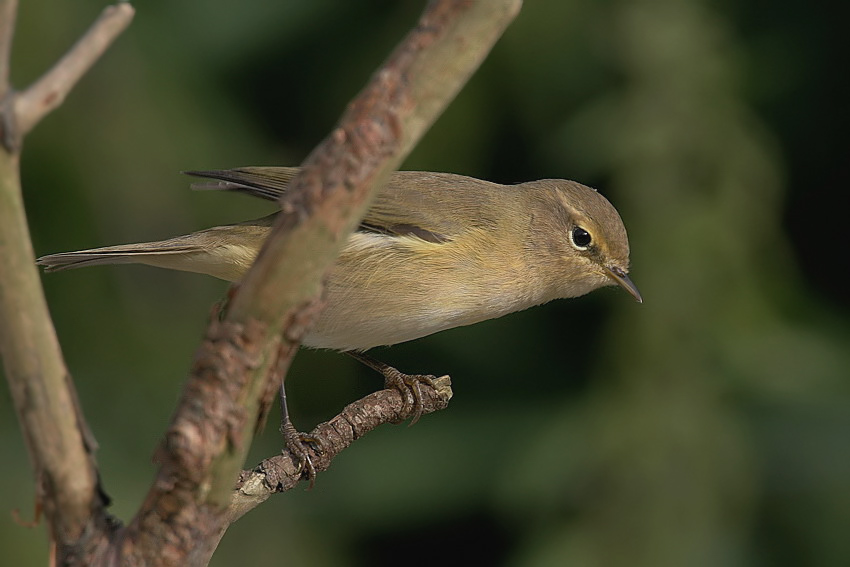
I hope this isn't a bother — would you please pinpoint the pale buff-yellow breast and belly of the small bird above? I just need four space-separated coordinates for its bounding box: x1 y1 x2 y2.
304 233 539 350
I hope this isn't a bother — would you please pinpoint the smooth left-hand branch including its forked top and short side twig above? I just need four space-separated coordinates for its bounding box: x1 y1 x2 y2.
0 0 132 559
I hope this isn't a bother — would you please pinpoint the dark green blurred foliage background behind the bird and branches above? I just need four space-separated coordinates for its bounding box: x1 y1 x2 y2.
0 0 850 567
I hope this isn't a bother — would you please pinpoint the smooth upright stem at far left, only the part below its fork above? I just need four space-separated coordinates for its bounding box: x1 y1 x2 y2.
0 151 97 544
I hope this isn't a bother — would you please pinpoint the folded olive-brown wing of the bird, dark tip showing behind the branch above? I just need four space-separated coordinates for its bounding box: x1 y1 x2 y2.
185 167 509 242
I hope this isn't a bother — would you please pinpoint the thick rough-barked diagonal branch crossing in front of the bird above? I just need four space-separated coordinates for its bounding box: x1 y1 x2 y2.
123 0 521 565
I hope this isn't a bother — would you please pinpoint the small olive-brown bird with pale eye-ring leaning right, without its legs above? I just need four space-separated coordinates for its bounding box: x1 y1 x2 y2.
37 167 642 352
